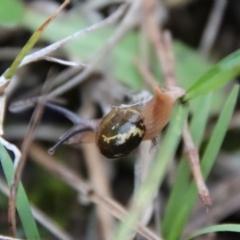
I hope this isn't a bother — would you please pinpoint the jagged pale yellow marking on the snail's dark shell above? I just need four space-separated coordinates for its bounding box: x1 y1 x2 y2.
102 126 144 144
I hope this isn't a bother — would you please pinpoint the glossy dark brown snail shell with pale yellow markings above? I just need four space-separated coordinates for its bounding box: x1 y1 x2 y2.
96 107 146 159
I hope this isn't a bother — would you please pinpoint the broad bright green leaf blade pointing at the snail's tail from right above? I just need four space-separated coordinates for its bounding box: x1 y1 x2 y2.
184 50 240 101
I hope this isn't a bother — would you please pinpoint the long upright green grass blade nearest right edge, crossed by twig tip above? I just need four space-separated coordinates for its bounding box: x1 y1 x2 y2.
166 86 239 240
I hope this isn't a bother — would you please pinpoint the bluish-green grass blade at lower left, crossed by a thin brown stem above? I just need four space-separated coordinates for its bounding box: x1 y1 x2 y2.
0 144 40 240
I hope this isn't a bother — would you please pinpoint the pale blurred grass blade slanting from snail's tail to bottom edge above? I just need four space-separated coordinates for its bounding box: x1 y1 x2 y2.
112 105 188 240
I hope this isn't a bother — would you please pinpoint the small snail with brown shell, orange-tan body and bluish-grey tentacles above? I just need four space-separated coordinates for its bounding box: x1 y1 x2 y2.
39 86 184 159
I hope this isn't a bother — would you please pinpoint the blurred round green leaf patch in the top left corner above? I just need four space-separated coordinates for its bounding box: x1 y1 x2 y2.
0 0 24 25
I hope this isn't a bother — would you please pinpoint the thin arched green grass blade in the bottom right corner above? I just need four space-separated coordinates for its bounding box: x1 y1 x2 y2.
186 224 240 240
